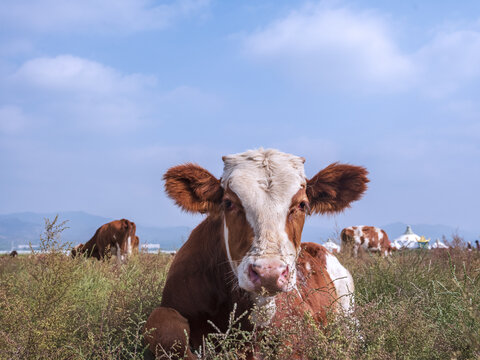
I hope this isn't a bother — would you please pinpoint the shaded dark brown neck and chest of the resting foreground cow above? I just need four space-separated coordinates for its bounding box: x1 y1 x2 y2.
162 211 282 336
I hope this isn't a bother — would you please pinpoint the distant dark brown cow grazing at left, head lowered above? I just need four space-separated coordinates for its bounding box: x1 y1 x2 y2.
72 219 138 261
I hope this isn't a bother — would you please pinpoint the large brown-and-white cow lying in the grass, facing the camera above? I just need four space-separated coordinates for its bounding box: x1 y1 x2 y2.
145 149 368 359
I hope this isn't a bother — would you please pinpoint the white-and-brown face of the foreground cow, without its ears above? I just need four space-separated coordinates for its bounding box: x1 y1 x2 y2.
221 150 308 294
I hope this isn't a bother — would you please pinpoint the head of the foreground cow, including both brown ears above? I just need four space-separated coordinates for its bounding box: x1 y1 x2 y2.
164 149 368 295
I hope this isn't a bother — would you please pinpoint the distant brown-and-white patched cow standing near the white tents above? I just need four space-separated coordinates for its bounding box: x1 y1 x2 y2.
340 225 396 256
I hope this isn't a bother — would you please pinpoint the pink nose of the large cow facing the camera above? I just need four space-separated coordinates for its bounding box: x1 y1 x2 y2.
248 261 290 294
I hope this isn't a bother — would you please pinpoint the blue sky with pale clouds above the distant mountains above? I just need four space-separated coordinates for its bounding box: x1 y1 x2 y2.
0 0 480 232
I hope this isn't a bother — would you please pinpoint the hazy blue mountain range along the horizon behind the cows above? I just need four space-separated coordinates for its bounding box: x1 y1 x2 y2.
0 211 478 251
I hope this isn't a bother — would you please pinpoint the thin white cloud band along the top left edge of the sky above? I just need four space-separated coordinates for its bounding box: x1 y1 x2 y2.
0 0 209 32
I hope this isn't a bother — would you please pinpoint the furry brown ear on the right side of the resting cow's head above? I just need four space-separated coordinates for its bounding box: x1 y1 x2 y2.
307 163 369 214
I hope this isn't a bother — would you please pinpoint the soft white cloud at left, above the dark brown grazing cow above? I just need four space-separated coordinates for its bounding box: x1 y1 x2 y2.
0 55 221 133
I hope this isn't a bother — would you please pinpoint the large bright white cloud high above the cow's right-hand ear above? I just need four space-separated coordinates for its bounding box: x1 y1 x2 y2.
245 6 415 88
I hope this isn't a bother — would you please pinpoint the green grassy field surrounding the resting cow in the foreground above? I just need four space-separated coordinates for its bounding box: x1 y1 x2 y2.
0 243 480 360
